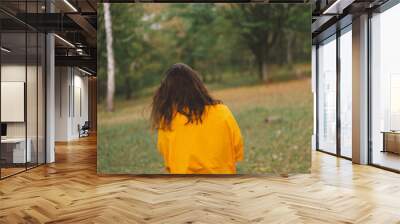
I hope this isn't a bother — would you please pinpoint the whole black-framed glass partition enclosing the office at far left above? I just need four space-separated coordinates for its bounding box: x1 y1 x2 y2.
0 1 46 178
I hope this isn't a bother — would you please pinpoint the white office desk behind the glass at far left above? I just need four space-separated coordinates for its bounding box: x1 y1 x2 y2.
1 138 32 163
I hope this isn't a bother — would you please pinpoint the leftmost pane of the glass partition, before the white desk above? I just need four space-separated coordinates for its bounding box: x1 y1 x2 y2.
0 32 27 177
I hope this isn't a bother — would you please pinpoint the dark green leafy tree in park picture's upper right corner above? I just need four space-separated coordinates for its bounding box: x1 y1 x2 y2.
225 4 311 77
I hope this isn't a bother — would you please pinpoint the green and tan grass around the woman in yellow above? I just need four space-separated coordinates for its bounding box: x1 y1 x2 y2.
98 78 313 174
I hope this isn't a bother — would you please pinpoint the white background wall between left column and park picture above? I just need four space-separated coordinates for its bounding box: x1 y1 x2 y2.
55 67 88 141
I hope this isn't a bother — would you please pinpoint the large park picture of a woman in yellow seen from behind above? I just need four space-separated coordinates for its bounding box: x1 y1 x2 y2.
97 3 313 175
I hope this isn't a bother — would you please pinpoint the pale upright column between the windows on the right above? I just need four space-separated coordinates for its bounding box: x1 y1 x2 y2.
352 15 368 164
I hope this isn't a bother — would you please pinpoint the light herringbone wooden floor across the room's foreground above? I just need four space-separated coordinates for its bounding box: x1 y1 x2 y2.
0 137 400 224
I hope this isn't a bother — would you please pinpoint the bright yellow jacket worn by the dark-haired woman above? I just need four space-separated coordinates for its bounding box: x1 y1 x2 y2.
157 104 243 174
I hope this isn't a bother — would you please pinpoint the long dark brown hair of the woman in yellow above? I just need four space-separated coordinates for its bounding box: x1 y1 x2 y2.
151 63 221 130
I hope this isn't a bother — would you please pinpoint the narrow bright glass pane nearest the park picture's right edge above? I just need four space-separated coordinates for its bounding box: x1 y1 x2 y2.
317 35 336 154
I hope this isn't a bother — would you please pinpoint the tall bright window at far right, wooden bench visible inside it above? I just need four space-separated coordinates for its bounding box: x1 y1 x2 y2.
370 1 400 170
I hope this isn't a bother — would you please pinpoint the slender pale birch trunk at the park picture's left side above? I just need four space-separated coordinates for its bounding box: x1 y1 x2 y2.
103 3 115 112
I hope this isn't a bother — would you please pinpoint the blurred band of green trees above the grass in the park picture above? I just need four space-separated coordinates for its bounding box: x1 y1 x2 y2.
98 3 311 100
